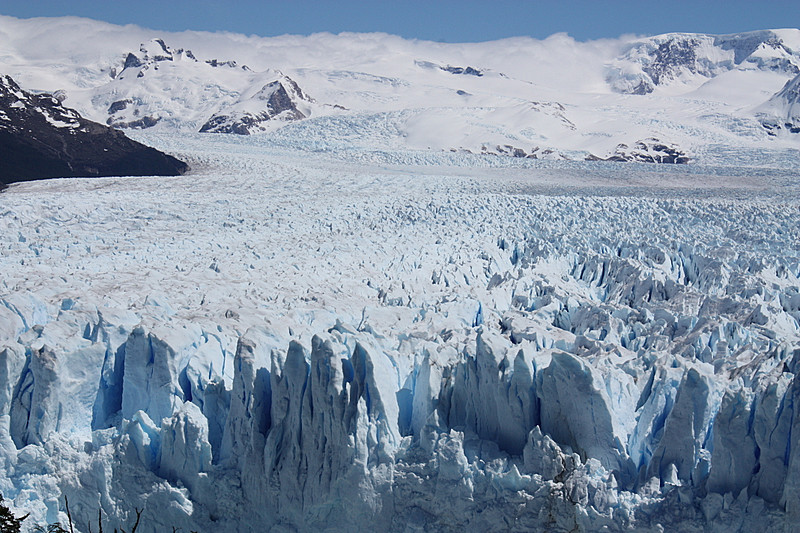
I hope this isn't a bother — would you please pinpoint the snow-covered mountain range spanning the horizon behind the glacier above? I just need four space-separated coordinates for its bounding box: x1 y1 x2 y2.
0 17 800 172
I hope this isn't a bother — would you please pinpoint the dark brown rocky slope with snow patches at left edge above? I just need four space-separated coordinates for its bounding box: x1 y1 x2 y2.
0 76 188 185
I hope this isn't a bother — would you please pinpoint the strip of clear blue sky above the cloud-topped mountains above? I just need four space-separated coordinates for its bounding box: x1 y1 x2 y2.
0 0 800 42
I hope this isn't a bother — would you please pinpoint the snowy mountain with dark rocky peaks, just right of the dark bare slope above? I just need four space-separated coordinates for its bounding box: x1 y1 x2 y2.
91 38 313 134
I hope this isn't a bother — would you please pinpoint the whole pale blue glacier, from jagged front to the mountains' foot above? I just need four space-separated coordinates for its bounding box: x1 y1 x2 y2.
0 132 800 531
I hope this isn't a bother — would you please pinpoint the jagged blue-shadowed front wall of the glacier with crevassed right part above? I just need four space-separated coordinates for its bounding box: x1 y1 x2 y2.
0 227 800 531
